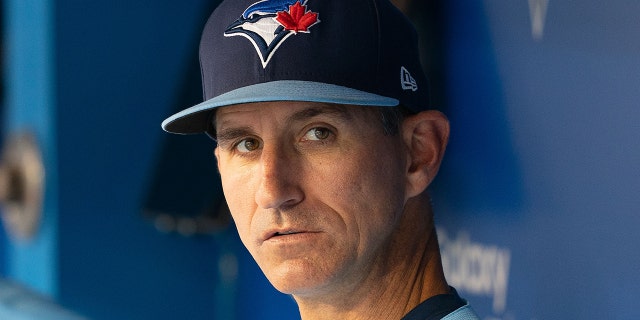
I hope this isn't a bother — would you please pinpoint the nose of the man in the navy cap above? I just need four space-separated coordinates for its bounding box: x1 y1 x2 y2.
256 147 304 209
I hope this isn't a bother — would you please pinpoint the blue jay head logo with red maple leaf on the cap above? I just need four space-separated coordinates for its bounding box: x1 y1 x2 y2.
224 0 320 68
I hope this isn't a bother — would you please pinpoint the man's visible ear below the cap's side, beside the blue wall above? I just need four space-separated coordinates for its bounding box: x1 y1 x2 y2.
402 110 449 199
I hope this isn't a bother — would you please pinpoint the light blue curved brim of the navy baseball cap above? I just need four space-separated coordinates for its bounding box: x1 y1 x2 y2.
162 80 399 134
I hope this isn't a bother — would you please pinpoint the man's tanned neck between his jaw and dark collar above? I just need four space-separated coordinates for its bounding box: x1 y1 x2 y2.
294 197 449 320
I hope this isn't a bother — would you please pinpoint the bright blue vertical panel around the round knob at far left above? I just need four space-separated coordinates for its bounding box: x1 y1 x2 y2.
2 1 58 295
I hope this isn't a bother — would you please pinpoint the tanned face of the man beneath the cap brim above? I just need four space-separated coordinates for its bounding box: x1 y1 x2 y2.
215 102 407 296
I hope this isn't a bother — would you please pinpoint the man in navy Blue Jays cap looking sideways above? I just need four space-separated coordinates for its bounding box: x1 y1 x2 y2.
162 0 476 319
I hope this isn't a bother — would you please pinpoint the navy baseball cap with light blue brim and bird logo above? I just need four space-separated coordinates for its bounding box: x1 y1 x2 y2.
162 0 429 134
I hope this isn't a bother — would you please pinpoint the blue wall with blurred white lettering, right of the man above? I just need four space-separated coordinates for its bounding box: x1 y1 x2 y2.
434 0 640 319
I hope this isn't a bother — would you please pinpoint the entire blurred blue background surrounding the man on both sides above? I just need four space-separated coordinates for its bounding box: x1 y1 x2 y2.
0 0 640 320
